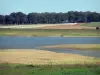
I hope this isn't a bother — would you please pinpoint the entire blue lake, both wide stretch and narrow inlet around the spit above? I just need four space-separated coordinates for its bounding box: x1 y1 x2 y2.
0 36 100 57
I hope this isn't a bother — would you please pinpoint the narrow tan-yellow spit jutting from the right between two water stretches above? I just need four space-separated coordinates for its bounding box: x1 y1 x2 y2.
41 44 100 50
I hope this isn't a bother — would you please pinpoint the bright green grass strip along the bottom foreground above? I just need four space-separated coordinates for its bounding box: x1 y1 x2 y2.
0 64 100 75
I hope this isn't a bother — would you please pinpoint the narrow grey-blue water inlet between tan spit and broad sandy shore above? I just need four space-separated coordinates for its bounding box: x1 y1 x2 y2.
41 48 100 57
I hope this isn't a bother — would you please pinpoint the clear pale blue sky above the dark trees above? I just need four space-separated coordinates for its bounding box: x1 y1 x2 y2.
0 0 100 15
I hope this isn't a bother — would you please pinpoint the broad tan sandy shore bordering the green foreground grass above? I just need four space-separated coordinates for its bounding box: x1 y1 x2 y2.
0 49 98 64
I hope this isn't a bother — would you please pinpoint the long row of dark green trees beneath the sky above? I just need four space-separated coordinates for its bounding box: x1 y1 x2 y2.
0 11 100 25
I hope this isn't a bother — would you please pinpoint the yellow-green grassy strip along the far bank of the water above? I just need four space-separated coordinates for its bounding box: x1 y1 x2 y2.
0 29 100 36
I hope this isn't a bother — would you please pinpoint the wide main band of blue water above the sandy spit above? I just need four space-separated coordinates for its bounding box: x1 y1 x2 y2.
0 36 100 49
